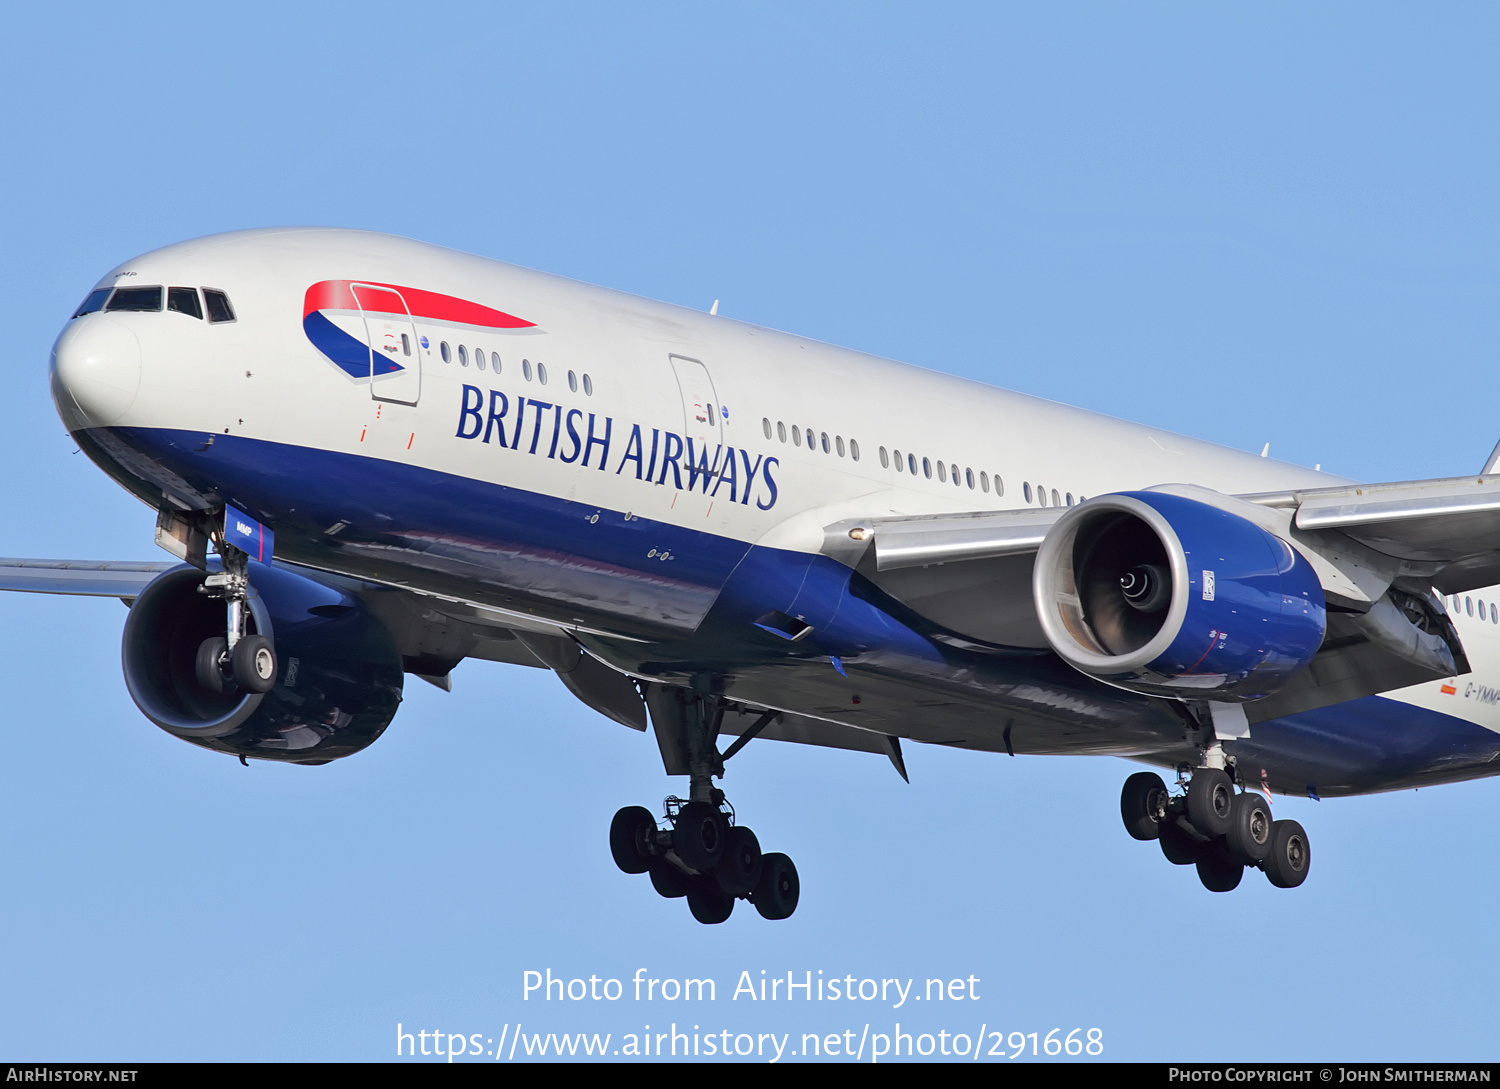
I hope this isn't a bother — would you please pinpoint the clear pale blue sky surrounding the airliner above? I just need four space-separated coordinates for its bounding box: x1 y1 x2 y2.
0 3 1500 1061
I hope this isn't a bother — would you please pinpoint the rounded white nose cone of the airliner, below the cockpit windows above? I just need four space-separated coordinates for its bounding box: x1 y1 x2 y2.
51 314 141 428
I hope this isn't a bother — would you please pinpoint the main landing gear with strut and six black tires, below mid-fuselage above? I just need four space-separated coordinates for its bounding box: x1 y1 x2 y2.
609 681 801 923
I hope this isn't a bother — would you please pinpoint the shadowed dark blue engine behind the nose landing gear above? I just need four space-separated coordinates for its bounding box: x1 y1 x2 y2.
122 564 404 764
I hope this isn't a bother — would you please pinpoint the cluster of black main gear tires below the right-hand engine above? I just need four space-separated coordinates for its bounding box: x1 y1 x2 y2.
1121 768 1313 893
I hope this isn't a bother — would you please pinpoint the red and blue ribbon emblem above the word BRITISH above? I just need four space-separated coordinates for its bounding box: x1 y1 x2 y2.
302 281 536 378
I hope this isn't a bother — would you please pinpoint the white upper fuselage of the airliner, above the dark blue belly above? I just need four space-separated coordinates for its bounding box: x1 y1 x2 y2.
57 228 1338 551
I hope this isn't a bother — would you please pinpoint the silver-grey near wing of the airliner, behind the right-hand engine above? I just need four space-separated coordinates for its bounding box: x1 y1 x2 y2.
824 474 1500 720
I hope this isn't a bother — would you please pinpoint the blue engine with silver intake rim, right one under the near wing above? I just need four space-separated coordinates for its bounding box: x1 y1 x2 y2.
1032 492 1326 702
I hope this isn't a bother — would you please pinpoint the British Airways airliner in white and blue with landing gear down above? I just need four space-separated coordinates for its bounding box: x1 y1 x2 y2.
20 228 1500 923
